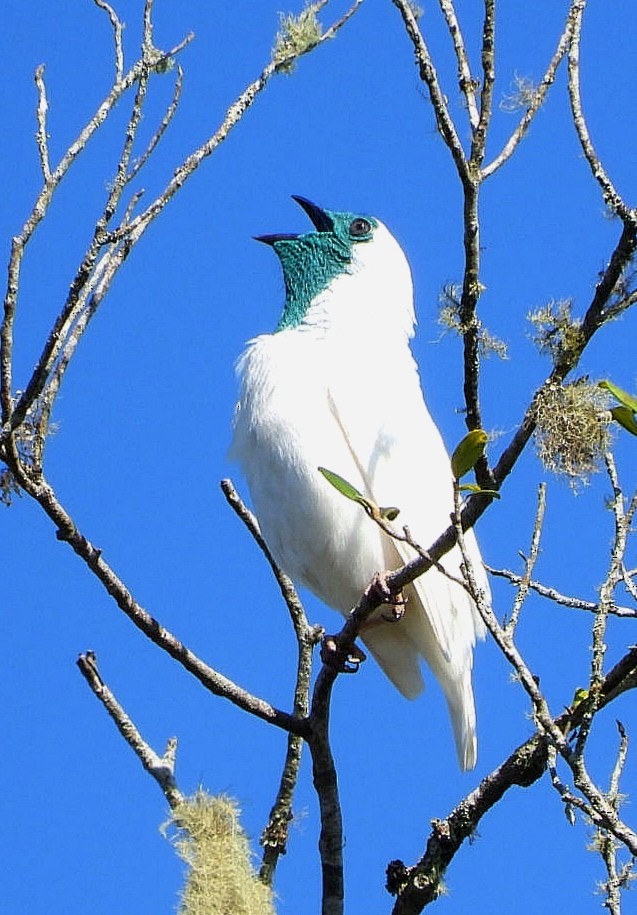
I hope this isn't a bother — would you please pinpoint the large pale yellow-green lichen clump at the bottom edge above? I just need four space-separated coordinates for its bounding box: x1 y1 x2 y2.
163 789 275 915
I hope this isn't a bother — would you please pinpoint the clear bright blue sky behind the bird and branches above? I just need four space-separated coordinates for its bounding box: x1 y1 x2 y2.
0 0 637 915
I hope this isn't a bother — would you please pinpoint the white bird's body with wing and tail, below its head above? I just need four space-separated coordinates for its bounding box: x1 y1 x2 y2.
232 331 487 768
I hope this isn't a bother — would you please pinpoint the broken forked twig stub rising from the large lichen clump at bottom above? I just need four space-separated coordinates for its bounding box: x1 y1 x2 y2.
77 651 184 809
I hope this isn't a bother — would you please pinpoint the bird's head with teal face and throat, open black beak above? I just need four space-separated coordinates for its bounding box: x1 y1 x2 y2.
255 195 413 333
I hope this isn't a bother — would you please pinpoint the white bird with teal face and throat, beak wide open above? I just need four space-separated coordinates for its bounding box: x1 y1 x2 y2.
230 197 489 769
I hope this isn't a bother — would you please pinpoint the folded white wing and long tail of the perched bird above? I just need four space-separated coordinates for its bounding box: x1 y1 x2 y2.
330 342 488 768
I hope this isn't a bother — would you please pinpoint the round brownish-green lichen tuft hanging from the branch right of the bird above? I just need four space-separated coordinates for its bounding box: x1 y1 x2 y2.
535 379 611 486
